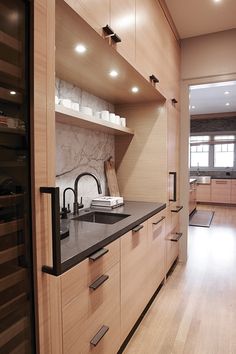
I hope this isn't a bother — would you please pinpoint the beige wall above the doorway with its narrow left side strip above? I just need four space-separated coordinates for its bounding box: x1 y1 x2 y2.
180 29 236 261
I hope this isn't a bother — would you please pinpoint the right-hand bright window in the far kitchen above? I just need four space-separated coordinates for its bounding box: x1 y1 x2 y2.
214 135 234 167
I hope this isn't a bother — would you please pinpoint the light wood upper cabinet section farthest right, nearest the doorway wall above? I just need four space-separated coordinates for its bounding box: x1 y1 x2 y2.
136 0 180 100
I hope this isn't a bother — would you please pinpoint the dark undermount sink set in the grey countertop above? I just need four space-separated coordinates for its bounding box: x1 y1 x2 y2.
72 211 130 224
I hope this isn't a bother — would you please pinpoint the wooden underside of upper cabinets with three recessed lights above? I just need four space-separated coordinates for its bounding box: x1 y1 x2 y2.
56 0 165 104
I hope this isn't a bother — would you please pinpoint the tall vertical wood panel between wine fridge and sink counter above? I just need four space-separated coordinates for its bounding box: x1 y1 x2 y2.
31 0 57 354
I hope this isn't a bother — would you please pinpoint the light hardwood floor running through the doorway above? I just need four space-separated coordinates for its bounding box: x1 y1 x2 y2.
124 205 236 354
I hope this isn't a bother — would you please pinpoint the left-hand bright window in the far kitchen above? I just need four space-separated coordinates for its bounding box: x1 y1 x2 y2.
190 135 210 167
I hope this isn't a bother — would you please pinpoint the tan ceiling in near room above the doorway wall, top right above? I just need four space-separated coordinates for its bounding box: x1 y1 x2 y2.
165 0 236 39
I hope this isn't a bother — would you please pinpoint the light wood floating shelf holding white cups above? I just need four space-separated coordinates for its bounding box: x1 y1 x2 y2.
56 105 134 135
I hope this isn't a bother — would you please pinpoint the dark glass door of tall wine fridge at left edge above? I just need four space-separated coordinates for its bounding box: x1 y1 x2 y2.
0 0 35 354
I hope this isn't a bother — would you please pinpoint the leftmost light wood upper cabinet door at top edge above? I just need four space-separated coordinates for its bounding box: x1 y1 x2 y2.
65 0 110 35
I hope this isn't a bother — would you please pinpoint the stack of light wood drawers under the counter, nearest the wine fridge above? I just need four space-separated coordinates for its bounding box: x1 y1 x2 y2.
61 239 120 354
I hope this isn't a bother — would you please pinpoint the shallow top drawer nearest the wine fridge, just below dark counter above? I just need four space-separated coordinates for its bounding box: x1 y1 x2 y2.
61 239 120 307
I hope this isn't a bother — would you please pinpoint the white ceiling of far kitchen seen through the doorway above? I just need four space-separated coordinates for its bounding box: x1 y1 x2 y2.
189 81 236 115
